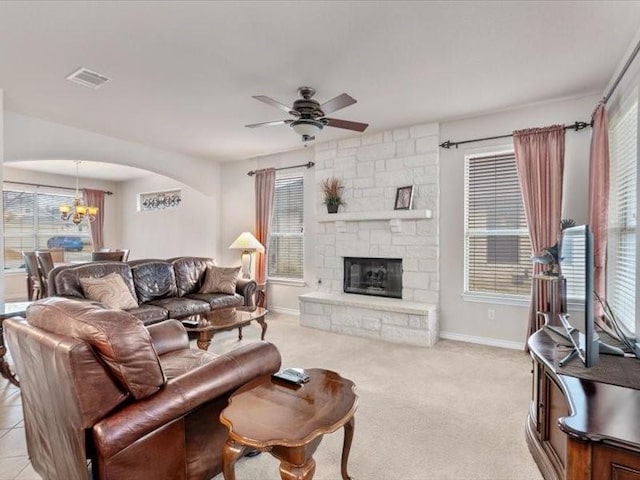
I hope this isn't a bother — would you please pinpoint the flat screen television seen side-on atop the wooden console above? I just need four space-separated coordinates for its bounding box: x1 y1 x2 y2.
558 225 600 367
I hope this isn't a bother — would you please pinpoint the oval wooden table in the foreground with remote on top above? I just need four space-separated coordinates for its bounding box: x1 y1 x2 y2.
220 368 358 480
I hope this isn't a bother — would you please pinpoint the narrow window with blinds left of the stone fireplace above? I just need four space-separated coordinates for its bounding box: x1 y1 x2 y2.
267 176 304 280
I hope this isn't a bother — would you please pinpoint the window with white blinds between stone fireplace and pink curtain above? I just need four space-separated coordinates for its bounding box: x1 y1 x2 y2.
464 152 532 299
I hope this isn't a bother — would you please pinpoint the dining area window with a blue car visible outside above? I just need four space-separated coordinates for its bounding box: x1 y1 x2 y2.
2 190 93 270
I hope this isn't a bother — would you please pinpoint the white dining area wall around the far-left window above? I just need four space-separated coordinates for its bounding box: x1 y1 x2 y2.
2 164 123 301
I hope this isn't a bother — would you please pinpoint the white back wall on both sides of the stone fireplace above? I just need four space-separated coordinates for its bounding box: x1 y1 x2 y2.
220 94 599 348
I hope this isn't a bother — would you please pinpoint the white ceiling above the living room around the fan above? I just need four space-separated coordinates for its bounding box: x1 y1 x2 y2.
0 1 640 180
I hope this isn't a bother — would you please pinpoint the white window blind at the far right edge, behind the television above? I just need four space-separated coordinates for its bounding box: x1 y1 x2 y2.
607 91 638 331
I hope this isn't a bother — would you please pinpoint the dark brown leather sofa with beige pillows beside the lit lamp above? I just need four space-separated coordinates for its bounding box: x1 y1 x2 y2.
48 257 256 325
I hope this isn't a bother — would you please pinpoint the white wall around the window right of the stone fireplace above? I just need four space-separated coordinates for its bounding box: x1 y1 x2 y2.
440 95 599 347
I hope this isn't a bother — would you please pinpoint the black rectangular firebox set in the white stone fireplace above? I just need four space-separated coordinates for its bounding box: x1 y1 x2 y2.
344 257 402 298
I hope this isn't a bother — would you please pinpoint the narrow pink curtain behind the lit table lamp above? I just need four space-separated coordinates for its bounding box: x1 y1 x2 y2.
255 168 276 294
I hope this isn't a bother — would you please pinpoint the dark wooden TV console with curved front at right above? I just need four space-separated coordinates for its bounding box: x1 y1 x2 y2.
525 329 640 480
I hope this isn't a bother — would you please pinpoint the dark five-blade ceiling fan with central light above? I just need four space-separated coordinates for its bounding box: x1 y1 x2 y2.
245 87 369 142
